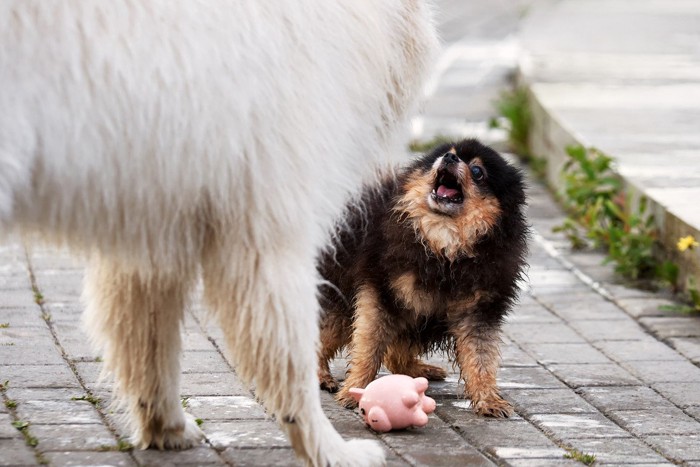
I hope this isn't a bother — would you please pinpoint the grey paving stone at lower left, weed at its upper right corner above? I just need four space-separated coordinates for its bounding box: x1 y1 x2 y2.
17 400 102 425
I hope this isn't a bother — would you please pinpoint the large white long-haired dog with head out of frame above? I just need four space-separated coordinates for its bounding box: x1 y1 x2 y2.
0 0 436 465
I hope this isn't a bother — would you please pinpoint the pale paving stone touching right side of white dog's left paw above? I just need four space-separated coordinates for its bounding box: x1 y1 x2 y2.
203 420 289 450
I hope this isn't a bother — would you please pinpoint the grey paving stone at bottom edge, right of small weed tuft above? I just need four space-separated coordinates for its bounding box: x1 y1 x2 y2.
572 438 667 465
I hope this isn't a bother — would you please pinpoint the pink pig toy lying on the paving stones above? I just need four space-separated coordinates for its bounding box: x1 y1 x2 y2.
350 375 435 432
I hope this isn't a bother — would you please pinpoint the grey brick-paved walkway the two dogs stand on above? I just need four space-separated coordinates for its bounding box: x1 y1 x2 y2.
0 0 700 466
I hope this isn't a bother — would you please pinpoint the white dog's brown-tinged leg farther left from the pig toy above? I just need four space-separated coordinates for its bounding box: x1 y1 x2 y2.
85 258 203 449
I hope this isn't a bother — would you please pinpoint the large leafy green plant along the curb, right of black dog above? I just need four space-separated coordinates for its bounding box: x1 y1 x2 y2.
554 146 660 280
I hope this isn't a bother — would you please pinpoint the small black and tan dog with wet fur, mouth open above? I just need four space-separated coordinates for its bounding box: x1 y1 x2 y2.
319 140 528 417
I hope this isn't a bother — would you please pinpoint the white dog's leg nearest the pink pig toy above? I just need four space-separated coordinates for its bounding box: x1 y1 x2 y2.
203 248 384 466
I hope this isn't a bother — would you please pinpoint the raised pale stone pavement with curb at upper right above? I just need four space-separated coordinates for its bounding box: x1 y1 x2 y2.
519 0 700 286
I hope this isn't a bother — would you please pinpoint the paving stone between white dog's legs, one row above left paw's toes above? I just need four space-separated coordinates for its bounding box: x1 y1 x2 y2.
187 396 268 421
